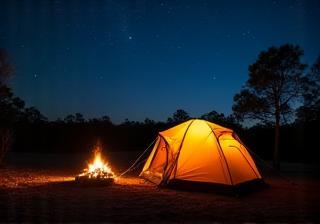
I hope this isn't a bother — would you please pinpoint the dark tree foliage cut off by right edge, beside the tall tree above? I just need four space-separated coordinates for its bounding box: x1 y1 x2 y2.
297 56 320 122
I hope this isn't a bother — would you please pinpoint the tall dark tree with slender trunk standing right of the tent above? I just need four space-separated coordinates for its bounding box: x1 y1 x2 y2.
232 44 307 168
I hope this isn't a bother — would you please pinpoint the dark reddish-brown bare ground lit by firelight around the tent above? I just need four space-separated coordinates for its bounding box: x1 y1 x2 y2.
0 154 320 222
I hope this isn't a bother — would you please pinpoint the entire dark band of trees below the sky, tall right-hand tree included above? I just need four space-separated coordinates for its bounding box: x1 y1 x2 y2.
0 44 320 167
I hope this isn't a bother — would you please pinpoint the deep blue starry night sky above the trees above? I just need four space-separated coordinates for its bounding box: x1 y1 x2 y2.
0 0 320 123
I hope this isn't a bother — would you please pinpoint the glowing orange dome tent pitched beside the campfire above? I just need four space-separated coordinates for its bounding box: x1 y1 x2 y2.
140 119 261 186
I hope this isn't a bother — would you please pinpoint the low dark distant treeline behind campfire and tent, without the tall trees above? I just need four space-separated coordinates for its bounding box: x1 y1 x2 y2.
8 110 320 162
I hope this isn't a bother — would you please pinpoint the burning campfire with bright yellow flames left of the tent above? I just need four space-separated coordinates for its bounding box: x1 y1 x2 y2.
75 144 116 184
